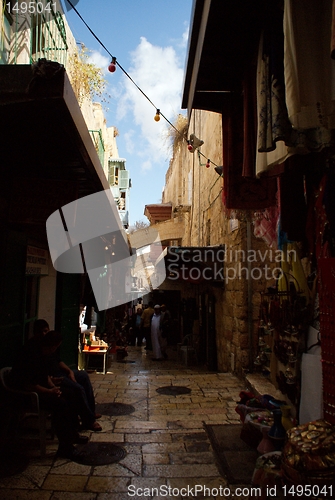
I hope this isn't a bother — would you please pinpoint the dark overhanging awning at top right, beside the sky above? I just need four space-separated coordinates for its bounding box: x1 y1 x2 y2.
182 0 264 113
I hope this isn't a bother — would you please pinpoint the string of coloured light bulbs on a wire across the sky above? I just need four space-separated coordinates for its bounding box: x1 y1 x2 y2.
66 0 221 168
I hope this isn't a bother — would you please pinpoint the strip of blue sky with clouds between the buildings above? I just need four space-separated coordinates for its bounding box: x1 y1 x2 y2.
64 0 192 224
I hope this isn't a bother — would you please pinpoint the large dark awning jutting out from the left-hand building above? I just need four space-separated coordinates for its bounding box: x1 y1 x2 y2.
0 62 109 240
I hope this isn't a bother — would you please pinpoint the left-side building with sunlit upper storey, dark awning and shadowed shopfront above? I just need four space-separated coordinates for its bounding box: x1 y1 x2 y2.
0 0 126 367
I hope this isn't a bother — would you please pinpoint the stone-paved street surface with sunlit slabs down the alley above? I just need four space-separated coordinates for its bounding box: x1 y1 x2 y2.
0 347 252 500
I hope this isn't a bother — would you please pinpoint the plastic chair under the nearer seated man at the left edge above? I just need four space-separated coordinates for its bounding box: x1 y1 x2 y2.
0 366 53 457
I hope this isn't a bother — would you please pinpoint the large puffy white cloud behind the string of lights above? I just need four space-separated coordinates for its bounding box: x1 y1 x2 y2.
117 37 183 171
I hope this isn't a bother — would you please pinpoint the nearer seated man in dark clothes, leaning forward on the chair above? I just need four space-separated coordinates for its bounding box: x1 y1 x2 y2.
9 332 88 461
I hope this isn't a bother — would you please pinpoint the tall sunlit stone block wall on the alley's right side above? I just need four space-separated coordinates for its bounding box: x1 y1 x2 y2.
163 110 274 374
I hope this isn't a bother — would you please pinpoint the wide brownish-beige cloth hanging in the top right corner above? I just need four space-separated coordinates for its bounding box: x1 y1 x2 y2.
284 0 335 131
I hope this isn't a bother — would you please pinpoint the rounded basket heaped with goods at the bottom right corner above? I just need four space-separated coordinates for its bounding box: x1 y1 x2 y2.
282 420 335 486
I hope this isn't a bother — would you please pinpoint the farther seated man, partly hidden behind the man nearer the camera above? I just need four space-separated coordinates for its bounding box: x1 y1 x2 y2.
33 319 102 432
